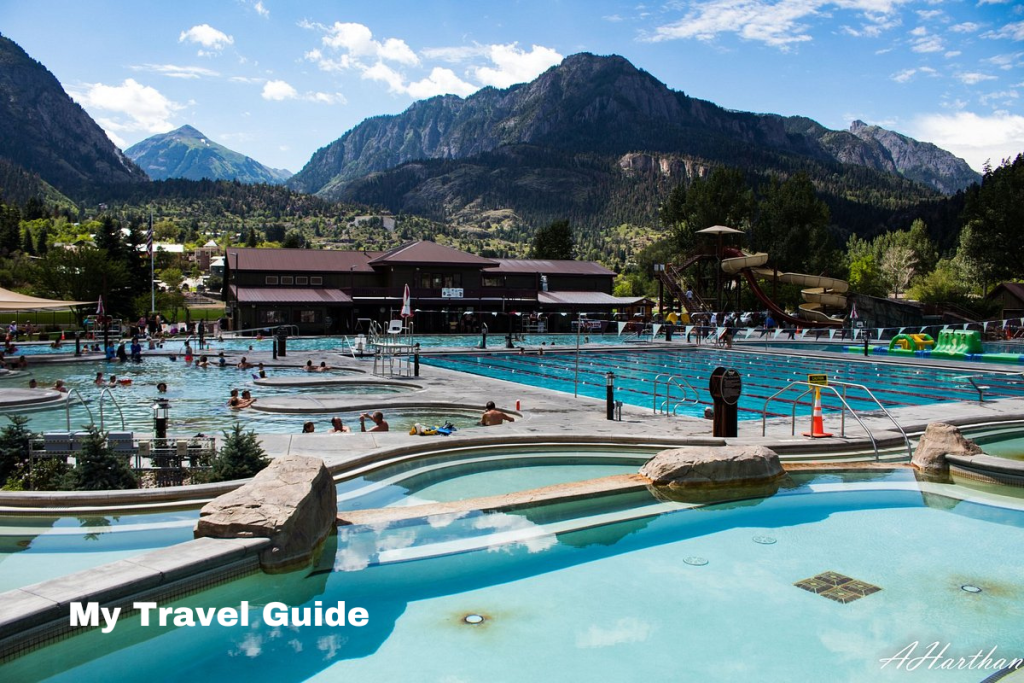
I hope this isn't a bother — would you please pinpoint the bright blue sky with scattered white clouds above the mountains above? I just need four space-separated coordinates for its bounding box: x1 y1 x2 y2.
0 0 1024 172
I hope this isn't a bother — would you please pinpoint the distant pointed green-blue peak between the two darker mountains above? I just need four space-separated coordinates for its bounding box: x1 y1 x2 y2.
125 126 292 184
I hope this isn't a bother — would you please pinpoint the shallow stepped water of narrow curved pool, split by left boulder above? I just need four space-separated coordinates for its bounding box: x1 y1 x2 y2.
0 446 653 592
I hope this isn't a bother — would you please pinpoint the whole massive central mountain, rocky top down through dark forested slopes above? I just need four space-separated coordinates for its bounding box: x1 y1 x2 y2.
288 53 977 229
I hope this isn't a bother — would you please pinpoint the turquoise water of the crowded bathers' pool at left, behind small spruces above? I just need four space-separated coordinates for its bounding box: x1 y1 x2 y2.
0 357 419 436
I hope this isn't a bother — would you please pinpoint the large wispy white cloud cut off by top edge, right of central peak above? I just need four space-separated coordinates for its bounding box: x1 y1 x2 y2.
648 0 908 50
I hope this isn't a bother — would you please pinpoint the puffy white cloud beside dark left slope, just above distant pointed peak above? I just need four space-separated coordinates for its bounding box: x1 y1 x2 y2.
71 78 183 139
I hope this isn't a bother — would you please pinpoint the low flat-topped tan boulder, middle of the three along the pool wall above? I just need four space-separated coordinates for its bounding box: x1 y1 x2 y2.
640 445 785 487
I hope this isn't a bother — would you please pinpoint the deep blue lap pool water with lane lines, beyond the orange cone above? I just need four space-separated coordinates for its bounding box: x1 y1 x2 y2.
421 347 1024 420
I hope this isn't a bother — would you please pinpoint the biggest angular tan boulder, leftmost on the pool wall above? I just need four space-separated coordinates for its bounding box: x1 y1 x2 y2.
195 456 338 572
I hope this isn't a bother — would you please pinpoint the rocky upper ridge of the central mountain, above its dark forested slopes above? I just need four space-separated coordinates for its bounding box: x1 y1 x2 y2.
289 53 980 197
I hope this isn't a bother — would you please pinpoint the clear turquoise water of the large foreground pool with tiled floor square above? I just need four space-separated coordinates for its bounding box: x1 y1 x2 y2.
0 474 1024 683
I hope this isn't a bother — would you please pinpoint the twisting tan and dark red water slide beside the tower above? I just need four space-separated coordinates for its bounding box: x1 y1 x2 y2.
722 249 850 328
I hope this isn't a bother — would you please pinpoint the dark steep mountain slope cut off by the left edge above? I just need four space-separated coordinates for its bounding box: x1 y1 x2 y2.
0 36 148 194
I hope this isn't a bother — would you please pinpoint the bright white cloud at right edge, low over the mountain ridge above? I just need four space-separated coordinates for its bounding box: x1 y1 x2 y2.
908 112 1024 171
